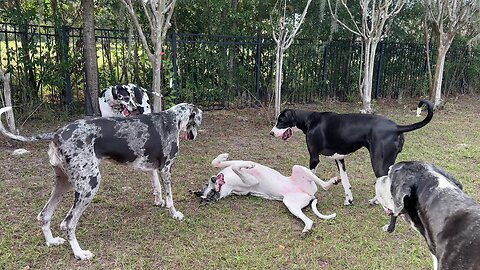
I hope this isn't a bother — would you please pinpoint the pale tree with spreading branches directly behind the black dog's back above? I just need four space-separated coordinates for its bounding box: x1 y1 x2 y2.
328 0 405 113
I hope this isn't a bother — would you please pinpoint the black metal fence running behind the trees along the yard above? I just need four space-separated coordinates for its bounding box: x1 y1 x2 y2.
0 24 480 111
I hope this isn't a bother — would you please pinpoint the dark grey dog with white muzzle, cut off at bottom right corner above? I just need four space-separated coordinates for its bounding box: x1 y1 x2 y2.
375 161 480 270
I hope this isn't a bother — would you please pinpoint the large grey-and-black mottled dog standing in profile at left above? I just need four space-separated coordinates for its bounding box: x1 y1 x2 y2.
0 103 202 260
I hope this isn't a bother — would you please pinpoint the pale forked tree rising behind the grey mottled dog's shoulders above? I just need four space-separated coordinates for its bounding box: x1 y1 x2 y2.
121 0 176 112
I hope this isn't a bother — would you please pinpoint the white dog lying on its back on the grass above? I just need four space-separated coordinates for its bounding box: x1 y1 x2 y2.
195 153 338 233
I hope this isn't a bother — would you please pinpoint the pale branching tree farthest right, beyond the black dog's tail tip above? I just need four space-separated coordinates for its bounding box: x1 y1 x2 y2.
423 0 480 109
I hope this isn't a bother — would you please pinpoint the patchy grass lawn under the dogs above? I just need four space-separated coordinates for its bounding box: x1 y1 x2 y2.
0 96 480 270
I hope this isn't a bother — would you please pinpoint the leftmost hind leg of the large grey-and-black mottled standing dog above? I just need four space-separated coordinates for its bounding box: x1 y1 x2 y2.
37 166 71 246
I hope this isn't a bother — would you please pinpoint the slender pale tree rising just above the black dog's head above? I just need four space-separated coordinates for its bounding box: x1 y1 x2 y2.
270 0 312 116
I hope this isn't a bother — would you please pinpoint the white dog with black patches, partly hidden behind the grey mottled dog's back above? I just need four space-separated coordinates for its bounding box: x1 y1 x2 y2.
98 84 152 117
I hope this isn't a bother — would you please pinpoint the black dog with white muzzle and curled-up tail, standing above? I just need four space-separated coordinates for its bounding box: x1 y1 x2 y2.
270 100 433 205
